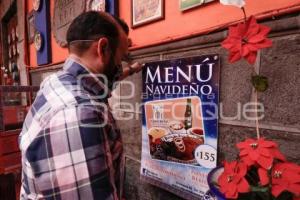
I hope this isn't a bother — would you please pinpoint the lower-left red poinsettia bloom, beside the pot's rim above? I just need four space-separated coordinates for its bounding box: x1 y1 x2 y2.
218 161 250 199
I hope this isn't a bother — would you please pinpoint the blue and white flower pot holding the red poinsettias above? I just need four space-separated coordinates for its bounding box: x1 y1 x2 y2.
207 167 226 200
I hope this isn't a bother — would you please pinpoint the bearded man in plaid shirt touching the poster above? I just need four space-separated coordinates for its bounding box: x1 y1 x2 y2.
20 11 141 200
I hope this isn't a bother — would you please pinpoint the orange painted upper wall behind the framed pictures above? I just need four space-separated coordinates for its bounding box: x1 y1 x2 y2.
27 0 300 67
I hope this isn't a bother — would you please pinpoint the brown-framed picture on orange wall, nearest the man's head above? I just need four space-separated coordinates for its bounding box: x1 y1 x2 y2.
131 0 165 28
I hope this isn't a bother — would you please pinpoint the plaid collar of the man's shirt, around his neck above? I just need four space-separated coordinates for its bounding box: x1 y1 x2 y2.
63 57 111 99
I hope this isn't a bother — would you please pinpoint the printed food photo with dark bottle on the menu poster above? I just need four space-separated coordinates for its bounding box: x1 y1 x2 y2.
145 96 205 165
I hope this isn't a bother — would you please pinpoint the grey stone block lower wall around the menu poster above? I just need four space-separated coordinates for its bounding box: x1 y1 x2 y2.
111 14 300 200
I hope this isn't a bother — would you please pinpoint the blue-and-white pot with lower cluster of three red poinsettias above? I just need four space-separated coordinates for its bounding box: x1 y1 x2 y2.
208 138 300 200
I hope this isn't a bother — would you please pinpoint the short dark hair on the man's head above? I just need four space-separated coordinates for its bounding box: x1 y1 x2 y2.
67 11 119 55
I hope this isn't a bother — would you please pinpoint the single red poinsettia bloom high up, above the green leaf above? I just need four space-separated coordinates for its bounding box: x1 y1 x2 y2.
222 16 272 64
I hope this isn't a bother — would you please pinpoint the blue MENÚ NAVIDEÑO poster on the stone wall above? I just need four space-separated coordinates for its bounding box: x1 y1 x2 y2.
140 55 220 199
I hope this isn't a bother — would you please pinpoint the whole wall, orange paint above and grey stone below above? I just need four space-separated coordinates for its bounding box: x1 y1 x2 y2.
22 0 300 200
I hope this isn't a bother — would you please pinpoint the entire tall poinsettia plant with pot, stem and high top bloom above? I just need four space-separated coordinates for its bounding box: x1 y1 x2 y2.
208 0 300 200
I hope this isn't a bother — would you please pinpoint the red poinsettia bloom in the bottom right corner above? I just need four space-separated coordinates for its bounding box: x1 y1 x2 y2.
271 163 300 199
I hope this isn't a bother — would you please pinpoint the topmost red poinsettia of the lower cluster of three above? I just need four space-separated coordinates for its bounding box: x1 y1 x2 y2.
237 138 285 169
